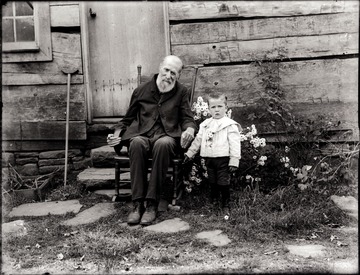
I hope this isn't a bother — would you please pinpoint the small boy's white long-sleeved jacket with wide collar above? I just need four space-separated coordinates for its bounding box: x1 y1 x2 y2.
186 117 241 167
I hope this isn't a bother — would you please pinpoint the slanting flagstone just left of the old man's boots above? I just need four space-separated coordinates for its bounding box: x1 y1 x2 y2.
62 202 115 226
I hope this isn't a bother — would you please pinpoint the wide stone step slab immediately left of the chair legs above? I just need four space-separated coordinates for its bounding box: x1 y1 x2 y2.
77 167 130 189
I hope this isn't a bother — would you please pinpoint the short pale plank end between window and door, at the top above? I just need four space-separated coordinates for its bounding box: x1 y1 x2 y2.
50 5 80 27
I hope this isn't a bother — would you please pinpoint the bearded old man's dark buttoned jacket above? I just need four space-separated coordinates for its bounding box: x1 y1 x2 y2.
115 74 197 141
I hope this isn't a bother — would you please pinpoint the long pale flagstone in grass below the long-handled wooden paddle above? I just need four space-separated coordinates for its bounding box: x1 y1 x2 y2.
9 200 82 217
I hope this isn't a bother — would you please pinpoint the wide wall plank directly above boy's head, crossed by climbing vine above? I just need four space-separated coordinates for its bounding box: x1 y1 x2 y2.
191 58 358 107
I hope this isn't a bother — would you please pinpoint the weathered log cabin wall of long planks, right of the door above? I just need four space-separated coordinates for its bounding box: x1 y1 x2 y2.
169 1 359 140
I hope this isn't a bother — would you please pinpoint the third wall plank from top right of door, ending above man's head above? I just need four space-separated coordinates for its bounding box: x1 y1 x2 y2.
172 33 359 64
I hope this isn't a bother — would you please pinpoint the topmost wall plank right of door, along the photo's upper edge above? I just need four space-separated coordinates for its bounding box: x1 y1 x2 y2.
169 0 359 20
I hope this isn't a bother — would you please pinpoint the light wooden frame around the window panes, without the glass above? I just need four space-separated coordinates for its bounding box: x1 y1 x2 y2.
2 1 52 63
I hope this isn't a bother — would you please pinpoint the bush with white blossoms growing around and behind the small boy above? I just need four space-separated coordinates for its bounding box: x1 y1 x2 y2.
183 97 358 195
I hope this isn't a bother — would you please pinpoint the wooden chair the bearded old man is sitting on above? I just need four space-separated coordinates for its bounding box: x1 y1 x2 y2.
113 66 194 205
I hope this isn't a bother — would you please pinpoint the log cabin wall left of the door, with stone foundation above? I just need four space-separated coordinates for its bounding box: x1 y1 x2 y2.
2 1 90 176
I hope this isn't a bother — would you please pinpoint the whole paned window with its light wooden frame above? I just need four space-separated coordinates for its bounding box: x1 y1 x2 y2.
2 1 52 63
